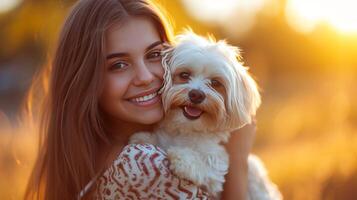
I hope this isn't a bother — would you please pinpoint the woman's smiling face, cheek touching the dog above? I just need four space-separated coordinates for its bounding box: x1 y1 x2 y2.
99 18 164 125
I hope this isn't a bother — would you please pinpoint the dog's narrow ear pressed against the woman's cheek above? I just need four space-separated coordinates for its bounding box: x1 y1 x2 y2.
159 46 174 112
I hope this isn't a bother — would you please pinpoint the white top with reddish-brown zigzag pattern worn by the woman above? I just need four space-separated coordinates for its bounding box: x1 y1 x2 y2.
90 144 211 200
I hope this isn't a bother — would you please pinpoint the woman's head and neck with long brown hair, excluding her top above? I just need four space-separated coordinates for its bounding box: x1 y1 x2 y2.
22 0 178 200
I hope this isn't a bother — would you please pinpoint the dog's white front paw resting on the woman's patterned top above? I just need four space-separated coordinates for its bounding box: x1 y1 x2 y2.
167 148 205 185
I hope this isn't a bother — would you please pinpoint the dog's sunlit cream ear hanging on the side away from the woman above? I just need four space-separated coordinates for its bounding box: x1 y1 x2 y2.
221 43 261 129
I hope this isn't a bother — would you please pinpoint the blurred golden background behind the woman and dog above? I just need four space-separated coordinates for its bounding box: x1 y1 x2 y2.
0 0 357 200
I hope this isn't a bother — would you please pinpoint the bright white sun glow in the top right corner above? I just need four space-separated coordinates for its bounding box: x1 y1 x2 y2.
285 0 357 33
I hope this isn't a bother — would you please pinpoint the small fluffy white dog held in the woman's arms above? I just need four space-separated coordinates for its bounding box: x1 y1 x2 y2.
130 31 281 199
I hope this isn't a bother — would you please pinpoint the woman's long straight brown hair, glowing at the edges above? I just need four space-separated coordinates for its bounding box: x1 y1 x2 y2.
25 0 172 200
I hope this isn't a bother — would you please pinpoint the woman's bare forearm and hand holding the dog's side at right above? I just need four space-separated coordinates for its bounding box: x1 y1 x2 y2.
221 119 256 200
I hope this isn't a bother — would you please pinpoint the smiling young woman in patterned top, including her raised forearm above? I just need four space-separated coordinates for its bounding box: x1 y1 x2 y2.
25 0 255 200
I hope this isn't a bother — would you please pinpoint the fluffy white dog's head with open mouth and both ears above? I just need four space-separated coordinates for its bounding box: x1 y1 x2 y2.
162 32 260 131
